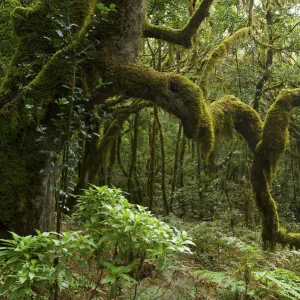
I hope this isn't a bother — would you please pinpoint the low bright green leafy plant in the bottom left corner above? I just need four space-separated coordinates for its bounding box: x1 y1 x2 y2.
0 231 95 300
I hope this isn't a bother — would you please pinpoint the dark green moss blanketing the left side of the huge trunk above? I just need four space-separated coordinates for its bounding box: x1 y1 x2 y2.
0 0 93 234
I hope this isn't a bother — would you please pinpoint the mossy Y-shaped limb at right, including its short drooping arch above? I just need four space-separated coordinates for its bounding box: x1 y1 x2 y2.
209 89 300 249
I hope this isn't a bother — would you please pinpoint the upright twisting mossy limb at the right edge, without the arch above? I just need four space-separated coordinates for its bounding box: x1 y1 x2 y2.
251 89 300 249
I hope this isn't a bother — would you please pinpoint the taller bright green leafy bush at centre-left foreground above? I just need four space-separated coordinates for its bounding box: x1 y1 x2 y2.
76 186 194 297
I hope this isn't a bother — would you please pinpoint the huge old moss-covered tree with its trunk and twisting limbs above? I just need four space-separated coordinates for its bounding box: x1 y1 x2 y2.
0 0 300 248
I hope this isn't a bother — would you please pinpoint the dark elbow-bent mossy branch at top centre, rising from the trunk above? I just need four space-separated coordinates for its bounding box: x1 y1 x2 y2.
143 0 213 48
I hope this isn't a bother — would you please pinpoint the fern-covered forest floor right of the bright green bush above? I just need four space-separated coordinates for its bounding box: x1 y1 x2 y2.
63 217 300 300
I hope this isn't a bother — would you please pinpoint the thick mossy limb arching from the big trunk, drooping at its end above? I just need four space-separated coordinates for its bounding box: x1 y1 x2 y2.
112 63 214 156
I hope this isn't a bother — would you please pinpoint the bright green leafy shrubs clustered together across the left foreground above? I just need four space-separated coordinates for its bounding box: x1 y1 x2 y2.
0 186 194 299
